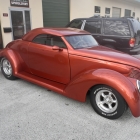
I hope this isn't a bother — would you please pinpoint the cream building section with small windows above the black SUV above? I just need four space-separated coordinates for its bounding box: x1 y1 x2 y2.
70 0 140 20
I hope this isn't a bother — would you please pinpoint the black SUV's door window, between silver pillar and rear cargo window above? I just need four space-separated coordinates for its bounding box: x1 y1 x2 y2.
84 20 101 34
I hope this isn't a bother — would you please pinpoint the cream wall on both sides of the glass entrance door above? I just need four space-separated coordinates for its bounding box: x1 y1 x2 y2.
0 0 43 47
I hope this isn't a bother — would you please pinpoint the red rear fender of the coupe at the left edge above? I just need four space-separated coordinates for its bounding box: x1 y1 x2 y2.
0 48 23 76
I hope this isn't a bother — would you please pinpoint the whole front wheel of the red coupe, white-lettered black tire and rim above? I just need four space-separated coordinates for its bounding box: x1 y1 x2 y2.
90 85 127 120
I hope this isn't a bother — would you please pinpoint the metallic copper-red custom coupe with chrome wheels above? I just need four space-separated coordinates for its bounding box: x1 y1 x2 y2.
0 28 140 119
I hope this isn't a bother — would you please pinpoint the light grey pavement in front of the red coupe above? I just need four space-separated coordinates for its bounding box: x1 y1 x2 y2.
0 64 140 140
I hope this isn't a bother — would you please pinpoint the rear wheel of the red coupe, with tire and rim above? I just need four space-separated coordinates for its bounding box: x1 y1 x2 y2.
1 57 16 80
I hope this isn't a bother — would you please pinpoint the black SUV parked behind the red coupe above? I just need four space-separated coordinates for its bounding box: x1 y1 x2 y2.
67 17 140 54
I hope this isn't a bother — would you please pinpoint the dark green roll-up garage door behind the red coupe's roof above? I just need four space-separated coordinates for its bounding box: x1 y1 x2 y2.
42 0 70 27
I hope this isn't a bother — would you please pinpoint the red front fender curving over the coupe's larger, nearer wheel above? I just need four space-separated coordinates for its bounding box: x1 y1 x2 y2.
65 69 140 117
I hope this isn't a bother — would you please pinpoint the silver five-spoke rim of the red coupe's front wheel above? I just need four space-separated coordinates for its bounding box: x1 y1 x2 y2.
95 90 118 113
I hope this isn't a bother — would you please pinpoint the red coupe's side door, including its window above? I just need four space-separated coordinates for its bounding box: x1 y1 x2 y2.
28 34 70 84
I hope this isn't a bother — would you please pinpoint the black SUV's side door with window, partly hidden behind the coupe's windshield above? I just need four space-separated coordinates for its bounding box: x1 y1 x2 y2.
84 19 102 44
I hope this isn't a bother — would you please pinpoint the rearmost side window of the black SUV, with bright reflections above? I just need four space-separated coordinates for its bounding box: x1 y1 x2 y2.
104 20 130 36
